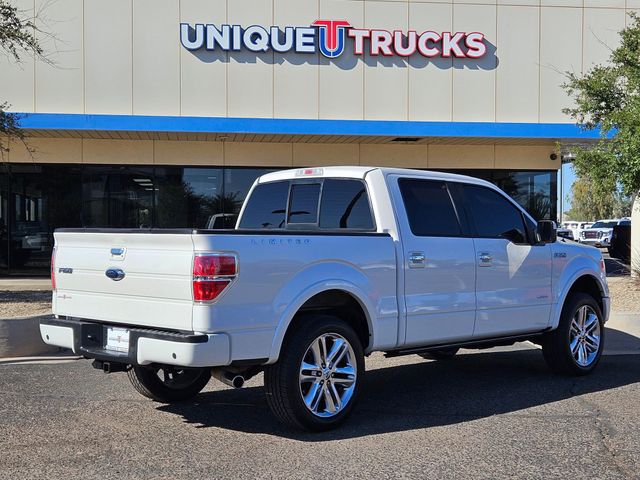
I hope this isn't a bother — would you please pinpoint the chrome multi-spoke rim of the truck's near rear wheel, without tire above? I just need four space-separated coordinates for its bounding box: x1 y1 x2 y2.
300 333 358 418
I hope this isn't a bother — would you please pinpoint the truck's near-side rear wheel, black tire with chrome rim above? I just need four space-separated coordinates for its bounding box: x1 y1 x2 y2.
264 315 365 431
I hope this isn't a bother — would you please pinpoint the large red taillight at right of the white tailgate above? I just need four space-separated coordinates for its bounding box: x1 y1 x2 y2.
193 254 238 302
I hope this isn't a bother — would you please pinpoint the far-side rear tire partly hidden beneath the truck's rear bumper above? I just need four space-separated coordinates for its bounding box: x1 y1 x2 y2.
127 366 211 403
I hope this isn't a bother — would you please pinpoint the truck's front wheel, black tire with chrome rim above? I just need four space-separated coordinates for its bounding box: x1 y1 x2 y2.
542 293 604 376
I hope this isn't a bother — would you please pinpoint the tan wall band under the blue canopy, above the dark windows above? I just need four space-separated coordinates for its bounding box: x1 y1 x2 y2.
5 138 559 170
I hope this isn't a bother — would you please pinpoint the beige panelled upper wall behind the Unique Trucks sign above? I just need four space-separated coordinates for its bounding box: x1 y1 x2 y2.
0 0 640 123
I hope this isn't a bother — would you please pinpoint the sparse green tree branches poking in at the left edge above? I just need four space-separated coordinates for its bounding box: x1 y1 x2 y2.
0 0 46 155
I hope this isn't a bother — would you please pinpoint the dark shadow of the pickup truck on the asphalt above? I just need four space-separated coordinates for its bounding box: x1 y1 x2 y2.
159 332 640 442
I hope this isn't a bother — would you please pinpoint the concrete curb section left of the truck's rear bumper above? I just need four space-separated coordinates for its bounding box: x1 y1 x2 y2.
0 315 62 358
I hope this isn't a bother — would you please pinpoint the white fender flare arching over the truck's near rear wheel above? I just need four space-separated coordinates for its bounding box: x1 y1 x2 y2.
267 279 375 364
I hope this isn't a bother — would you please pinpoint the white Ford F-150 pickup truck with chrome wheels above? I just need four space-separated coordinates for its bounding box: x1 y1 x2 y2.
40 167 609 430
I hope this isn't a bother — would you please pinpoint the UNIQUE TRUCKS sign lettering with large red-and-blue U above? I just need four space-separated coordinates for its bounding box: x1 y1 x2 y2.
180 20 487 58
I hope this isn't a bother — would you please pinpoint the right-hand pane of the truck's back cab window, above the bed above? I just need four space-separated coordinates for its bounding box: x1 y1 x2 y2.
320 179 374 230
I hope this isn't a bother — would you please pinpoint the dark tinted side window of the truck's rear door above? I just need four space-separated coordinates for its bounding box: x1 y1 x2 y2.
398 178 462 237
